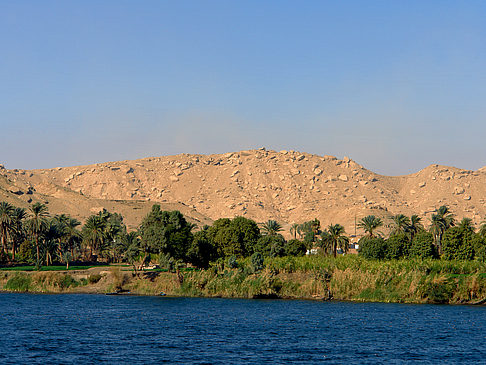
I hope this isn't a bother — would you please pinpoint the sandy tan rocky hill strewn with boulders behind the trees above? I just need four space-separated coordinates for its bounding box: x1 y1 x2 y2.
0 148 486 234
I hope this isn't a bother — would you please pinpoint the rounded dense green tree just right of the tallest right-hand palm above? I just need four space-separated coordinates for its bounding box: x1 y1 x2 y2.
442 226 474 260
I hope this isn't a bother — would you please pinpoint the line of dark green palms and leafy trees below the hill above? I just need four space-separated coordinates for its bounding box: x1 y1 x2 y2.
0 202 486 270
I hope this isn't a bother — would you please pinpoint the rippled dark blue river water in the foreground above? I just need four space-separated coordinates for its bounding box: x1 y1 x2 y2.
0 293 486 364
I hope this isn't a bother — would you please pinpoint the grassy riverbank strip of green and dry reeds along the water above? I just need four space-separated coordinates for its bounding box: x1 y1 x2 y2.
0 255 486 304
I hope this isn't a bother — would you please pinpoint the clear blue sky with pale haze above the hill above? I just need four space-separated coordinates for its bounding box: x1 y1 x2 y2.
0 0 486 175
